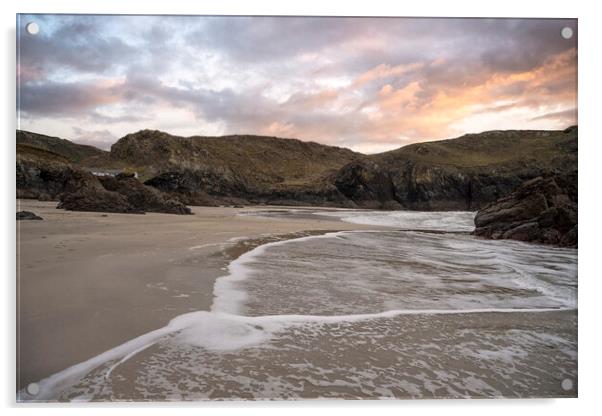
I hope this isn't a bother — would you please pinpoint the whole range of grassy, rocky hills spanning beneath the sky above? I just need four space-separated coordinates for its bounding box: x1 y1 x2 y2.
17 127 578 211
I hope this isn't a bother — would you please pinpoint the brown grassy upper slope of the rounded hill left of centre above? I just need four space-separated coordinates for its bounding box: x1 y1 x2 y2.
111 130 363 186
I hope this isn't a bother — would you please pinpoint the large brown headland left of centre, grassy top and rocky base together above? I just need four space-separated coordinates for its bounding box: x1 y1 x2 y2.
111 130 365 206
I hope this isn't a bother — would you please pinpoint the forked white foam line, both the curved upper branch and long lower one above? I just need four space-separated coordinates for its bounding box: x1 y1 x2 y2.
17 226 575 401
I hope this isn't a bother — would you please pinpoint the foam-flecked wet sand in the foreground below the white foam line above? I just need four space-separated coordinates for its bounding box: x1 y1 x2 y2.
62 311 578 402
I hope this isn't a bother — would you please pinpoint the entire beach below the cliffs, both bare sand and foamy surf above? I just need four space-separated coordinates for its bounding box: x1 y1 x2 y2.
18 201 577 402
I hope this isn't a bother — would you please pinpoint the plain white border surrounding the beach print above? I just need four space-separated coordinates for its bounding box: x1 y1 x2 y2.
0 0 602 416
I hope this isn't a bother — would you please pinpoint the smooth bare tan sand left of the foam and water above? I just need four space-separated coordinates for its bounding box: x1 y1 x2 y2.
17 200 377 389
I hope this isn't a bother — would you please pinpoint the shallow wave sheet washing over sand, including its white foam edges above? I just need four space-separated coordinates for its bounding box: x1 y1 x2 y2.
17 212 576 401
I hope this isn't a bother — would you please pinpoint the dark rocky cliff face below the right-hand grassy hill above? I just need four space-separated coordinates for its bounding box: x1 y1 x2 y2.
333 160 550 211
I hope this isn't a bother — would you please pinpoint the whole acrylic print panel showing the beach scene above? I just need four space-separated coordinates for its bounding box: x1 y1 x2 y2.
16 14 578 402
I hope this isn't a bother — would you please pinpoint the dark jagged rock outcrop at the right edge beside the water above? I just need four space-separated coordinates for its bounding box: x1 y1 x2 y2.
474 173 577 247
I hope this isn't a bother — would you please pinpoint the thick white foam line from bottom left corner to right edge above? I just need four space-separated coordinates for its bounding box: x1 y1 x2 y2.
17 308 571 401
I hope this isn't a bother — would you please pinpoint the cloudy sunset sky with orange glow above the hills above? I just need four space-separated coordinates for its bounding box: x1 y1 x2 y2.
17 15 577 153
